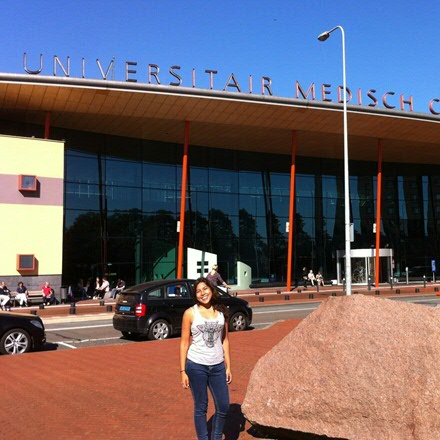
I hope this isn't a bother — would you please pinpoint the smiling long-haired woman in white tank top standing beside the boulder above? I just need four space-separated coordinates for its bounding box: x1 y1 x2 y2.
180 278 232 440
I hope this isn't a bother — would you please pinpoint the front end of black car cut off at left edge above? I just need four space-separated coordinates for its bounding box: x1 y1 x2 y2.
0 312 46 354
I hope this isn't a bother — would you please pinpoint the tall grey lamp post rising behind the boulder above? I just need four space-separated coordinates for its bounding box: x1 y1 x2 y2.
318 26 351 295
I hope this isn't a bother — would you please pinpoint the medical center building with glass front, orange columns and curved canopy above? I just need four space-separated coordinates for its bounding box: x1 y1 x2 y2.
0 72 440 294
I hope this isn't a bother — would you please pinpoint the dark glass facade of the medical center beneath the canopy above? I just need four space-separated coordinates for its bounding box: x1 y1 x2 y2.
1 118 440 285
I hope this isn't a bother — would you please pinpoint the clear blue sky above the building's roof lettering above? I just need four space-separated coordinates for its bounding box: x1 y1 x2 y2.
0 0 440 113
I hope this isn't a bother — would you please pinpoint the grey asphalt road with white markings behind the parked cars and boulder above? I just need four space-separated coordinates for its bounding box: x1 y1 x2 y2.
44 296 440 350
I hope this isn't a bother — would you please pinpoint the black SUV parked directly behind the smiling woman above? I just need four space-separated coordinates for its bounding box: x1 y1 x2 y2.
113 279 252 339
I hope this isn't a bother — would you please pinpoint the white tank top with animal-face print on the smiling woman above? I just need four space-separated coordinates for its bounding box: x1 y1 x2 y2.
187 305 225 365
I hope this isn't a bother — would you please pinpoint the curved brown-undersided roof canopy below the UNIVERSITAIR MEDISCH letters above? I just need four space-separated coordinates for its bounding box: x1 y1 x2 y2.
0 73 440 164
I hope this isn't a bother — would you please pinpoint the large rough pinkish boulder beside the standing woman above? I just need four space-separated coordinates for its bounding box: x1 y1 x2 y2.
242 295 440 440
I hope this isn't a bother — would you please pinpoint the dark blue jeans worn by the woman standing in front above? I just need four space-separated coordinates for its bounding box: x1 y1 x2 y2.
186 359 229 440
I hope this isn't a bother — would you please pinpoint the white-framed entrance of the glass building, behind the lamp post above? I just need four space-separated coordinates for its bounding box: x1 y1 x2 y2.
337 248 393 284
